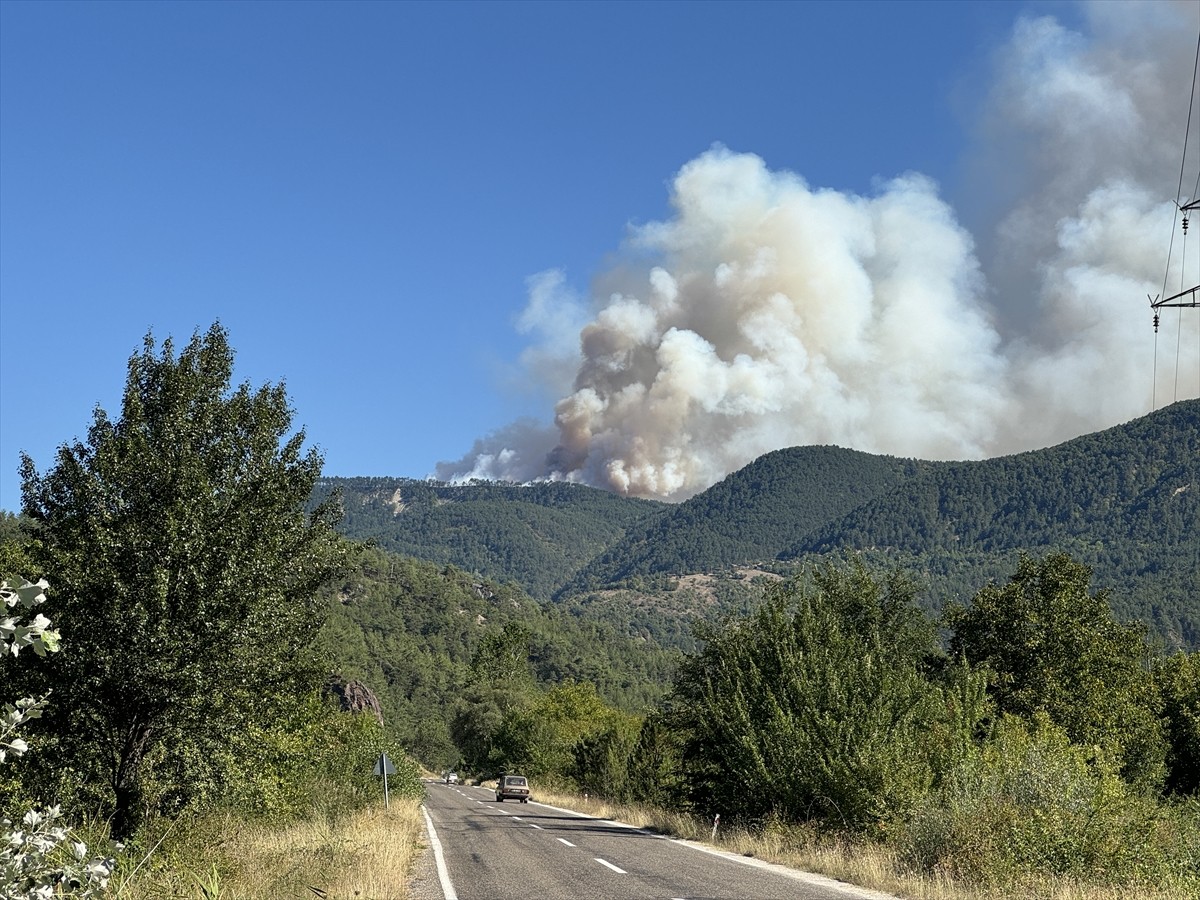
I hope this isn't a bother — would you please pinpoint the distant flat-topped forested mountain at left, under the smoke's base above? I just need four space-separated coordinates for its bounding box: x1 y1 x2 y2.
313 478 670 599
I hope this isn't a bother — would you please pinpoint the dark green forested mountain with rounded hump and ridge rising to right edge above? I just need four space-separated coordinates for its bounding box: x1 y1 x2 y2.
559 401 1200 647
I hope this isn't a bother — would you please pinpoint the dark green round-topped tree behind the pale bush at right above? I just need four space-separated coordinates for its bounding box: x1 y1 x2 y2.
944 553 1165 786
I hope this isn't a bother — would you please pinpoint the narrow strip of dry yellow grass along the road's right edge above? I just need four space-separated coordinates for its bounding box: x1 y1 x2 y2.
535 788 1198 900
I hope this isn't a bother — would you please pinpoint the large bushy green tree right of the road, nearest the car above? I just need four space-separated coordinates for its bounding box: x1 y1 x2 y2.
672 566 947 828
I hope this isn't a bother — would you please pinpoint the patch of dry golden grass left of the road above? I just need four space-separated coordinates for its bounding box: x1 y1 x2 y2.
114 799 425 900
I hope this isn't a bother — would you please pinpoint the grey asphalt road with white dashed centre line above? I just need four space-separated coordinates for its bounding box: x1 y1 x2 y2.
425 781 887 900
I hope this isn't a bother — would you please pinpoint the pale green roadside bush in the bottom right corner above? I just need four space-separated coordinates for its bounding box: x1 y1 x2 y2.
896 715 1200 888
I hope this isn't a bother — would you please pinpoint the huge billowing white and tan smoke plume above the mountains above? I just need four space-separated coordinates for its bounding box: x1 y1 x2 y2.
438 2 1200 499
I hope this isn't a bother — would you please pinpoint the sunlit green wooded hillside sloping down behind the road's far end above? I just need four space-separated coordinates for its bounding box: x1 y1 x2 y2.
319 547 679 762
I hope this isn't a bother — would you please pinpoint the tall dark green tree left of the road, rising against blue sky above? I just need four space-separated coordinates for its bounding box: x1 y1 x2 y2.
20 323 344 838
